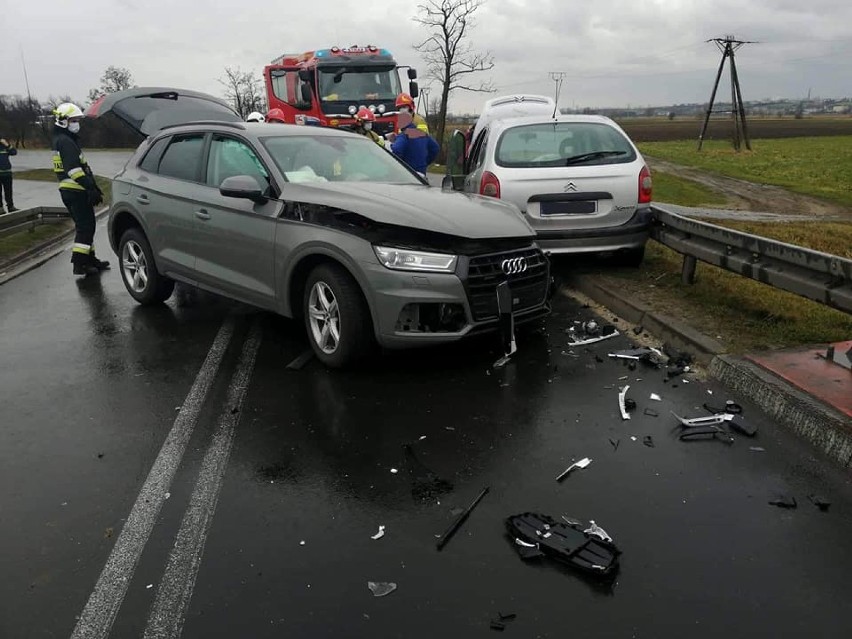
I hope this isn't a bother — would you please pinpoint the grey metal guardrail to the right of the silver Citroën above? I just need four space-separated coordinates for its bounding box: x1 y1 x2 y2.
651 206 852 313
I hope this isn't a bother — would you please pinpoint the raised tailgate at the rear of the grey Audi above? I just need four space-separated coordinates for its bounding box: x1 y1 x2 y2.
86 87 242 136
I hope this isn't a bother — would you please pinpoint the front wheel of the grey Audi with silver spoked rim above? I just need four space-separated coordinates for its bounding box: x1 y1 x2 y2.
302 264 375 368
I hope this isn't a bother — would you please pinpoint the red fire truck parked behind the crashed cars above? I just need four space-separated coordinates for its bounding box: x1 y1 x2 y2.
263 45 418 135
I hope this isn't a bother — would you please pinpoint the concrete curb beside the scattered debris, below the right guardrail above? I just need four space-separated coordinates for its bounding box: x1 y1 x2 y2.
566 275 852 468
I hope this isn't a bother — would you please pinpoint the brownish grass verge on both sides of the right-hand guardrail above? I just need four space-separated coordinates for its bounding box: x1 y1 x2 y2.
597 220 852 353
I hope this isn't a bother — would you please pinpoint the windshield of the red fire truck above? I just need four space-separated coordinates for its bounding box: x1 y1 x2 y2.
319 66 401 103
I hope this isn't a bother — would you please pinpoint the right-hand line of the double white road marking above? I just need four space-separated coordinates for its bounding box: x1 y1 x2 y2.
143 322 262 639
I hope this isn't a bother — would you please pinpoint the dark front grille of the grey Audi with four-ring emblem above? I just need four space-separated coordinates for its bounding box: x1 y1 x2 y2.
465 248 550 322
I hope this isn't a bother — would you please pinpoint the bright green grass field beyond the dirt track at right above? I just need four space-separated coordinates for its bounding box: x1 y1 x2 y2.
637 135 852 206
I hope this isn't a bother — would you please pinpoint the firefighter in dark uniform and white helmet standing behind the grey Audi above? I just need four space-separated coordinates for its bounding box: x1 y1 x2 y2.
53 104 109 275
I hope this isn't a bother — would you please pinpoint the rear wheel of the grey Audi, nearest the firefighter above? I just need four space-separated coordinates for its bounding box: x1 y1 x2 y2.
118 228 175 306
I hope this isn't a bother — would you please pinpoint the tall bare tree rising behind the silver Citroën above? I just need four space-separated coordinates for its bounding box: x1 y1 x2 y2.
413 0 494 144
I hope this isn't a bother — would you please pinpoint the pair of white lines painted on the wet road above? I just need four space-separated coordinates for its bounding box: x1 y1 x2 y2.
71 317 262 639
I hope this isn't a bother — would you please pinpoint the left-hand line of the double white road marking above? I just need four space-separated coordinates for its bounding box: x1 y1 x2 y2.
71 317 234 639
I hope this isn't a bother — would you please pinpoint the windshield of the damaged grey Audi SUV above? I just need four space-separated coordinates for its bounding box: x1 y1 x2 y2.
262 133 421 184
